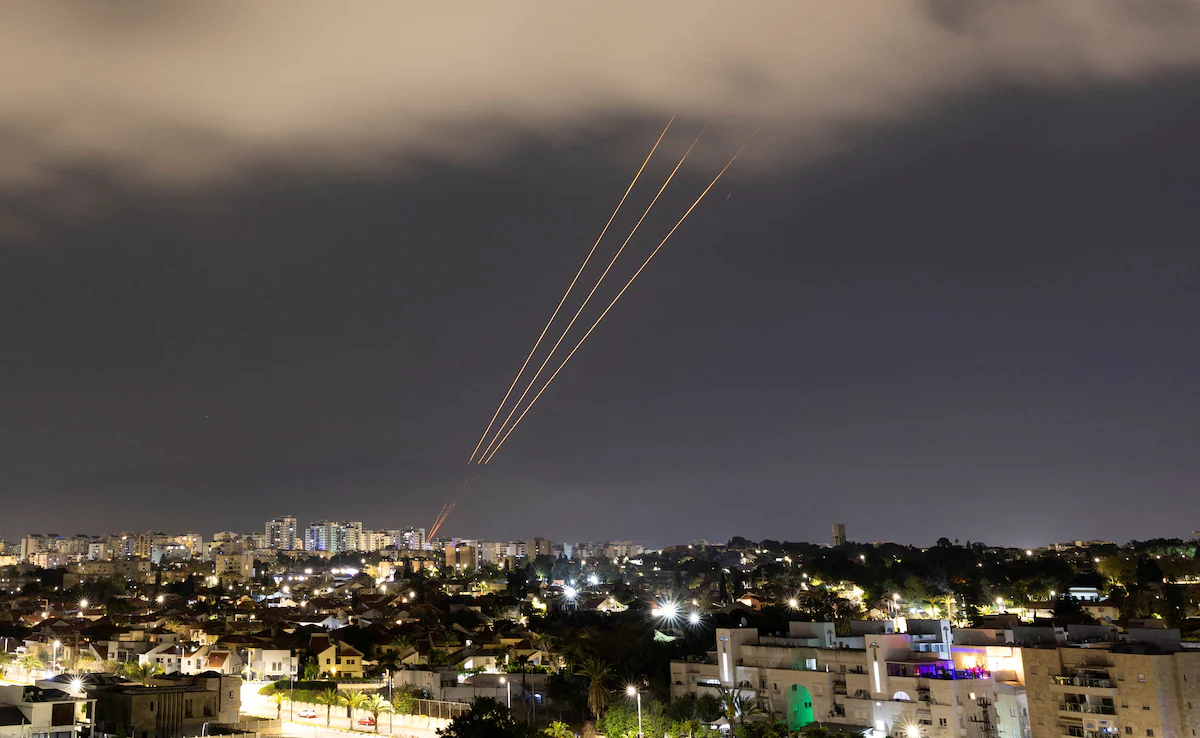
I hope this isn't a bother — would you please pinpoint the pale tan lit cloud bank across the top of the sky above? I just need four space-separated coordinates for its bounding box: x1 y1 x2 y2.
7 0 1200 233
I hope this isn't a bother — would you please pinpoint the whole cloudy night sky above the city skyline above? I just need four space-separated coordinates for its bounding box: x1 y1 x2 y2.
0 1 1200 546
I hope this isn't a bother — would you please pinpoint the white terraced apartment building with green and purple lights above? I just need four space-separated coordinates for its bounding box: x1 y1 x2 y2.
671 620 1020 738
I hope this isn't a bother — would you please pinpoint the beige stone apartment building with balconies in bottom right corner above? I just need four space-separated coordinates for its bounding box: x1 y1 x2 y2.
1022 628 1200 738
